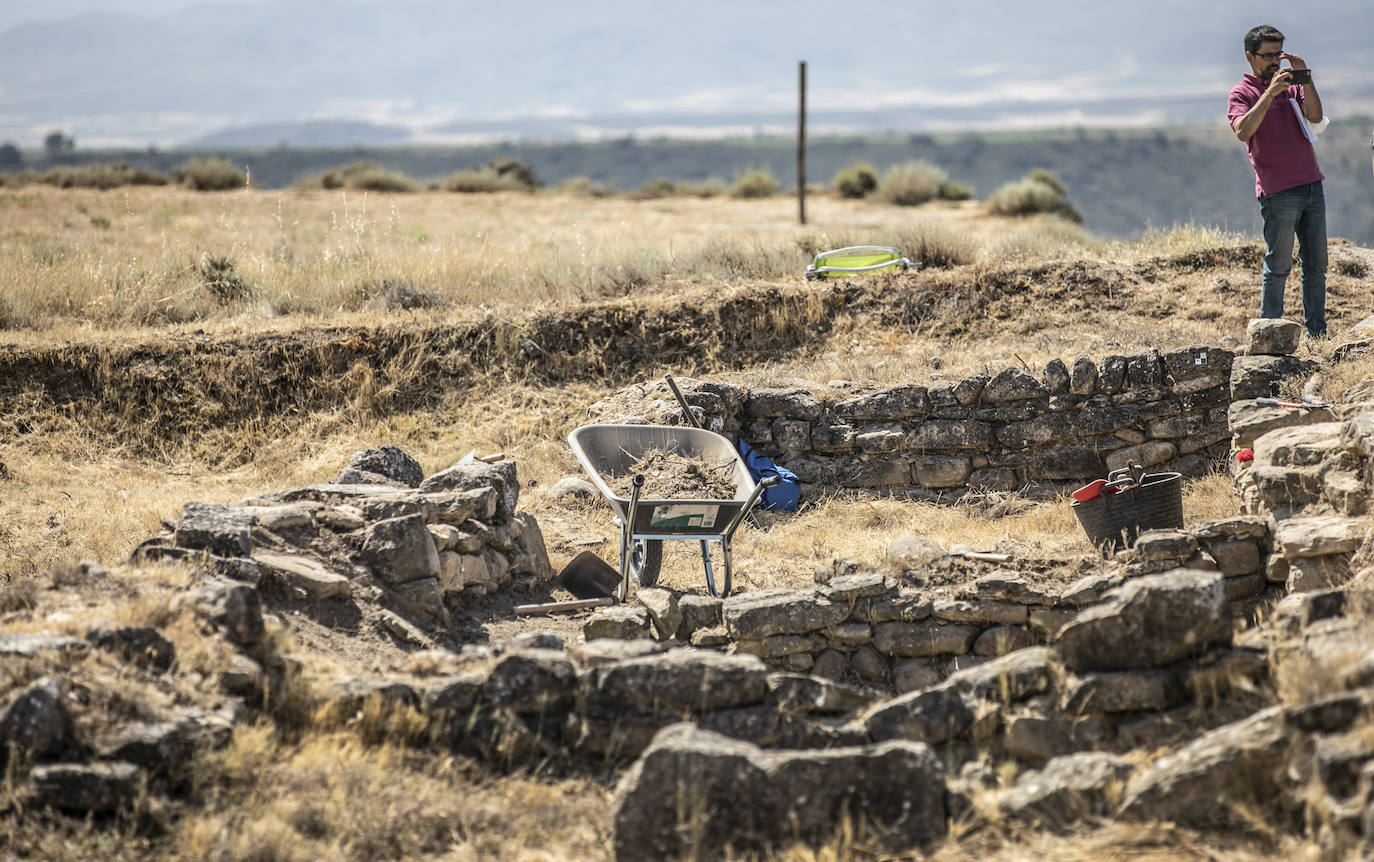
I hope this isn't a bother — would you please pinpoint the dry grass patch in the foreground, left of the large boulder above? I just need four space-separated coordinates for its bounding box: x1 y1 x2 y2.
168 726 609 862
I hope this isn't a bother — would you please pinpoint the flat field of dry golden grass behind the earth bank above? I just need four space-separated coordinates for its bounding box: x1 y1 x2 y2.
0 187 1022 337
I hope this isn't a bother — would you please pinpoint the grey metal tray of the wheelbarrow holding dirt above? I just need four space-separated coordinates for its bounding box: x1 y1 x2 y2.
567 425 754 538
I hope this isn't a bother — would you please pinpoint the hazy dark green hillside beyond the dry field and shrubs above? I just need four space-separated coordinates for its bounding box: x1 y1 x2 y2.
16 117 1374 245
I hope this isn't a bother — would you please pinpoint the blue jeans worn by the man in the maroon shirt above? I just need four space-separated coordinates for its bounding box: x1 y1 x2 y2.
1260 181 1326 337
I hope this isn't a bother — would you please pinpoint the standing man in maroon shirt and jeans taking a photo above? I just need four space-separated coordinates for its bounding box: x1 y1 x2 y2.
1226 26 1326 338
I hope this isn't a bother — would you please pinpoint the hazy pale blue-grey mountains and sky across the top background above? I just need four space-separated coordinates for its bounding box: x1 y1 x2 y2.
0 0 1374 147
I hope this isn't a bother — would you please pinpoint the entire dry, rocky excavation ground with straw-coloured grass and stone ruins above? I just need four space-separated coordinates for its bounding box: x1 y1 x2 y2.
0 187 1374 862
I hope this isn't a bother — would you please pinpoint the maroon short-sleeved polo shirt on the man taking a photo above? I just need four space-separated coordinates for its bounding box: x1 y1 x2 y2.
1226 74 1322 197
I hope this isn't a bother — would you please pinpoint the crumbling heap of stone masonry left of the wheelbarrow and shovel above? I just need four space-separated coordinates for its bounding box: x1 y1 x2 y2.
135 447 552 623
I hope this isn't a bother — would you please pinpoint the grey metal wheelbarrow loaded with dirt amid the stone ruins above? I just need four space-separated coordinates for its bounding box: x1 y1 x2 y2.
567 425 778 601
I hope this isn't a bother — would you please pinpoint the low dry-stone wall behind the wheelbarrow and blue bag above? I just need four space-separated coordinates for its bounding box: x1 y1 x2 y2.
588 345 1235 495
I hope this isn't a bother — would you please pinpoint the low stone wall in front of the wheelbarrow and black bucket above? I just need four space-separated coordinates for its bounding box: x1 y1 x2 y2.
583 517 1275 693
